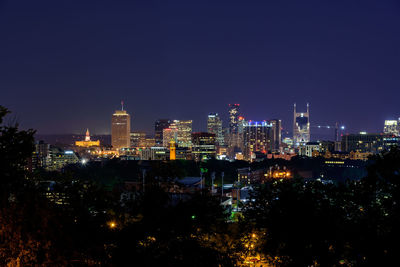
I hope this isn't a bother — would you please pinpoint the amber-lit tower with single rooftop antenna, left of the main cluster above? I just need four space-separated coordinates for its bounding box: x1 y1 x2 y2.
111 105 131 149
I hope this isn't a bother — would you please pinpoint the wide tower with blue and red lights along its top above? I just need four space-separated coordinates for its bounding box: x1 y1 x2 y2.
243 121 272 160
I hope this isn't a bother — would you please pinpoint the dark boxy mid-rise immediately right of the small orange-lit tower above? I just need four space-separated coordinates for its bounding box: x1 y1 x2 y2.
192 132 217 161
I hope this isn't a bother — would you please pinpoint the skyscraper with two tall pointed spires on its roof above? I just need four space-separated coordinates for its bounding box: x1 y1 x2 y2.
293 103 310 147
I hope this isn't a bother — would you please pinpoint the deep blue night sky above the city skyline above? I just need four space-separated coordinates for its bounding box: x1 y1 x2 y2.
0 0 400 137
